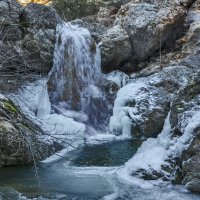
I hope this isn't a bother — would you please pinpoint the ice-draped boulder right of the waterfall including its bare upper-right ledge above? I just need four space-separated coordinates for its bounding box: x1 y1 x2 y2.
110 66 193 137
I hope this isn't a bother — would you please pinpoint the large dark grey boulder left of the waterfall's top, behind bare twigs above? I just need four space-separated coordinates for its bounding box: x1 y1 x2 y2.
0 0 59 83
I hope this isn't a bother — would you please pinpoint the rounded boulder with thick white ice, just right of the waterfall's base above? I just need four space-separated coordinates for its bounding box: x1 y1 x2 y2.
109 78 169 137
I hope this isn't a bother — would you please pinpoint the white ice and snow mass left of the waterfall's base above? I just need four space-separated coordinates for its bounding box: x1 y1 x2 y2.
12 79 87 154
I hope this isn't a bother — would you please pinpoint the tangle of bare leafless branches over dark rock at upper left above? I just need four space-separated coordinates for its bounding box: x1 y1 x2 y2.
0 0 54 92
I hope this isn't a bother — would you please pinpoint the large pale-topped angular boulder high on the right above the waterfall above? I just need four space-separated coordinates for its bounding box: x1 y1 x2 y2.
115 2 186 68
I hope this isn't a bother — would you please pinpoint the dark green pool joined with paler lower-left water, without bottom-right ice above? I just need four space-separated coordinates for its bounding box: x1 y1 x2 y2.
0 140 142 200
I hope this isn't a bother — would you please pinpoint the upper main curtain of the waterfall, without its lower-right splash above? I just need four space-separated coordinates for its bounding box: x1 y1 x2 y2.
50 22 101 106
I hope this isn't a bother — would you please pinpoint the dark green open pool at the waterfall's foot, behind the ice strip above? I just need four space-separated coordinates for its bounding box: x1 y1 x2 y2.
71 139 143 166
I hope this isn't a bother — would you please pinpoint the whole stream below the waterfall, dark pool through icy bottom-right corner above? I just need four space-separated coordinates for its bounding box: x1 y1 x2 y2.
0 140 200 200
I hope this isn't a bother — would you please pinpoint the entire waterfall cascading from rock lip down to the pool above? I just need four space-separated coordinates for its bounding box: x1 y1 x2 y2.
48 22 111 130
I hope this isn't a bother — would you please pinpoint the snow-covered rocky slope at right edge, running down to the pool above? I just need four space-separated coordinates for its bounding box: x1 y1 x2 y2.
117 77 200 180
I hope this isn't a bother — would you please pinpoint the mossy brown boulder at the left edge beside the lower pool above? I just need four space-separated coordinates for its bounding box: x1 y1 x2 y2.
0 95 61 166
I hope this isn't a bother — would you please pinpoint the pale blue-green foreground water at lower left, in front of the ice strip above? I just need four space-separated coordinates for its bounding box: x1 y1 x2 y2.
0 163 112 200
